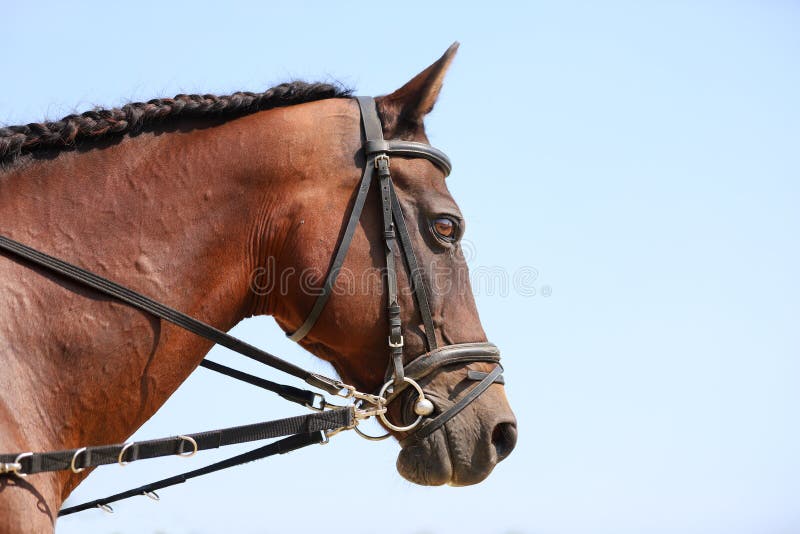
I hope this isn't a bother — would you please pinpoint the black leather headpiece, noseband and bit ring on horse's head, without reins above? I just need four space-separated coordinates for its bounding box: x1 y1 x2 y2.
289 96 503 441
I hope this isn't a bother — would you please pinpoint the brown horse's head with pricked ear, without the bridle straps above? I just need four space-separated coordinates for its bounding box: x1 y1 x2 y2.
262 45 517 485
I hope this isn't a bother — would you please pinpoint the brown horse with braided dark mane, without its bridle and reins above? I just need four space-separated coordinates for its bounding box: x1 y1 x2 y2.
0 45 516 534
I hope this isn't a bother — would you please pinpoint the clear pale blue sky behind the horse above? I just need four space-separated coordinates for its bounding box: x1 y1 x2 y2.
0 0 800 534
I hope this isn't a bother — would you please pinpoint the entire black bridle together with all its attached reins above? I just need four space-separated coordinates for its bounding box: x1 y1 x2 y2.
0 97 503 515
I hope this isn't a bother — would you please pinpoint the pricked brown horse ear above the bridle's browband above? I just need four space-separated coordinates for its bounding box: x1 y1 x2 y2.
376 41 459 135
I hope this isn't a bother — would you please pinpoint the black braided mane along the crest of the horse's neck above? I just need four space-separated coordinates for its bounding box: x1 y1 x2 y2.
0 82 351 164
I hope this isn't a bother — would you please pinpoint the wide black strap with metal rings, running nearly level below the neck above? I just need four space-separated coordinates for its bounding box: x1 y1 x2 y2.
0 407 353 474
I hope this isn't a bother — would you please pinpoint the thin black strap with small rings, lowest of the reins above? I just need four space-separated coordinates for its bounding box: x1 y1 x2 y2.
58 432 325 517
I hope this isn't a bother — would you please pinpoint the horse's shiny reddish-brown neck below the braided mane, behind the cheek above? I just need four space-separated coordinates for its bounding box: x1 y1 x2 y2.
0 116 300 460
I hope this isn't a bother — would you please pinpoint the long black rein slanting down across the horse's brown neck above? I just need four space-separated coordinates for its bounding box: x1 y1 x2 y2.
0 235 341 393
